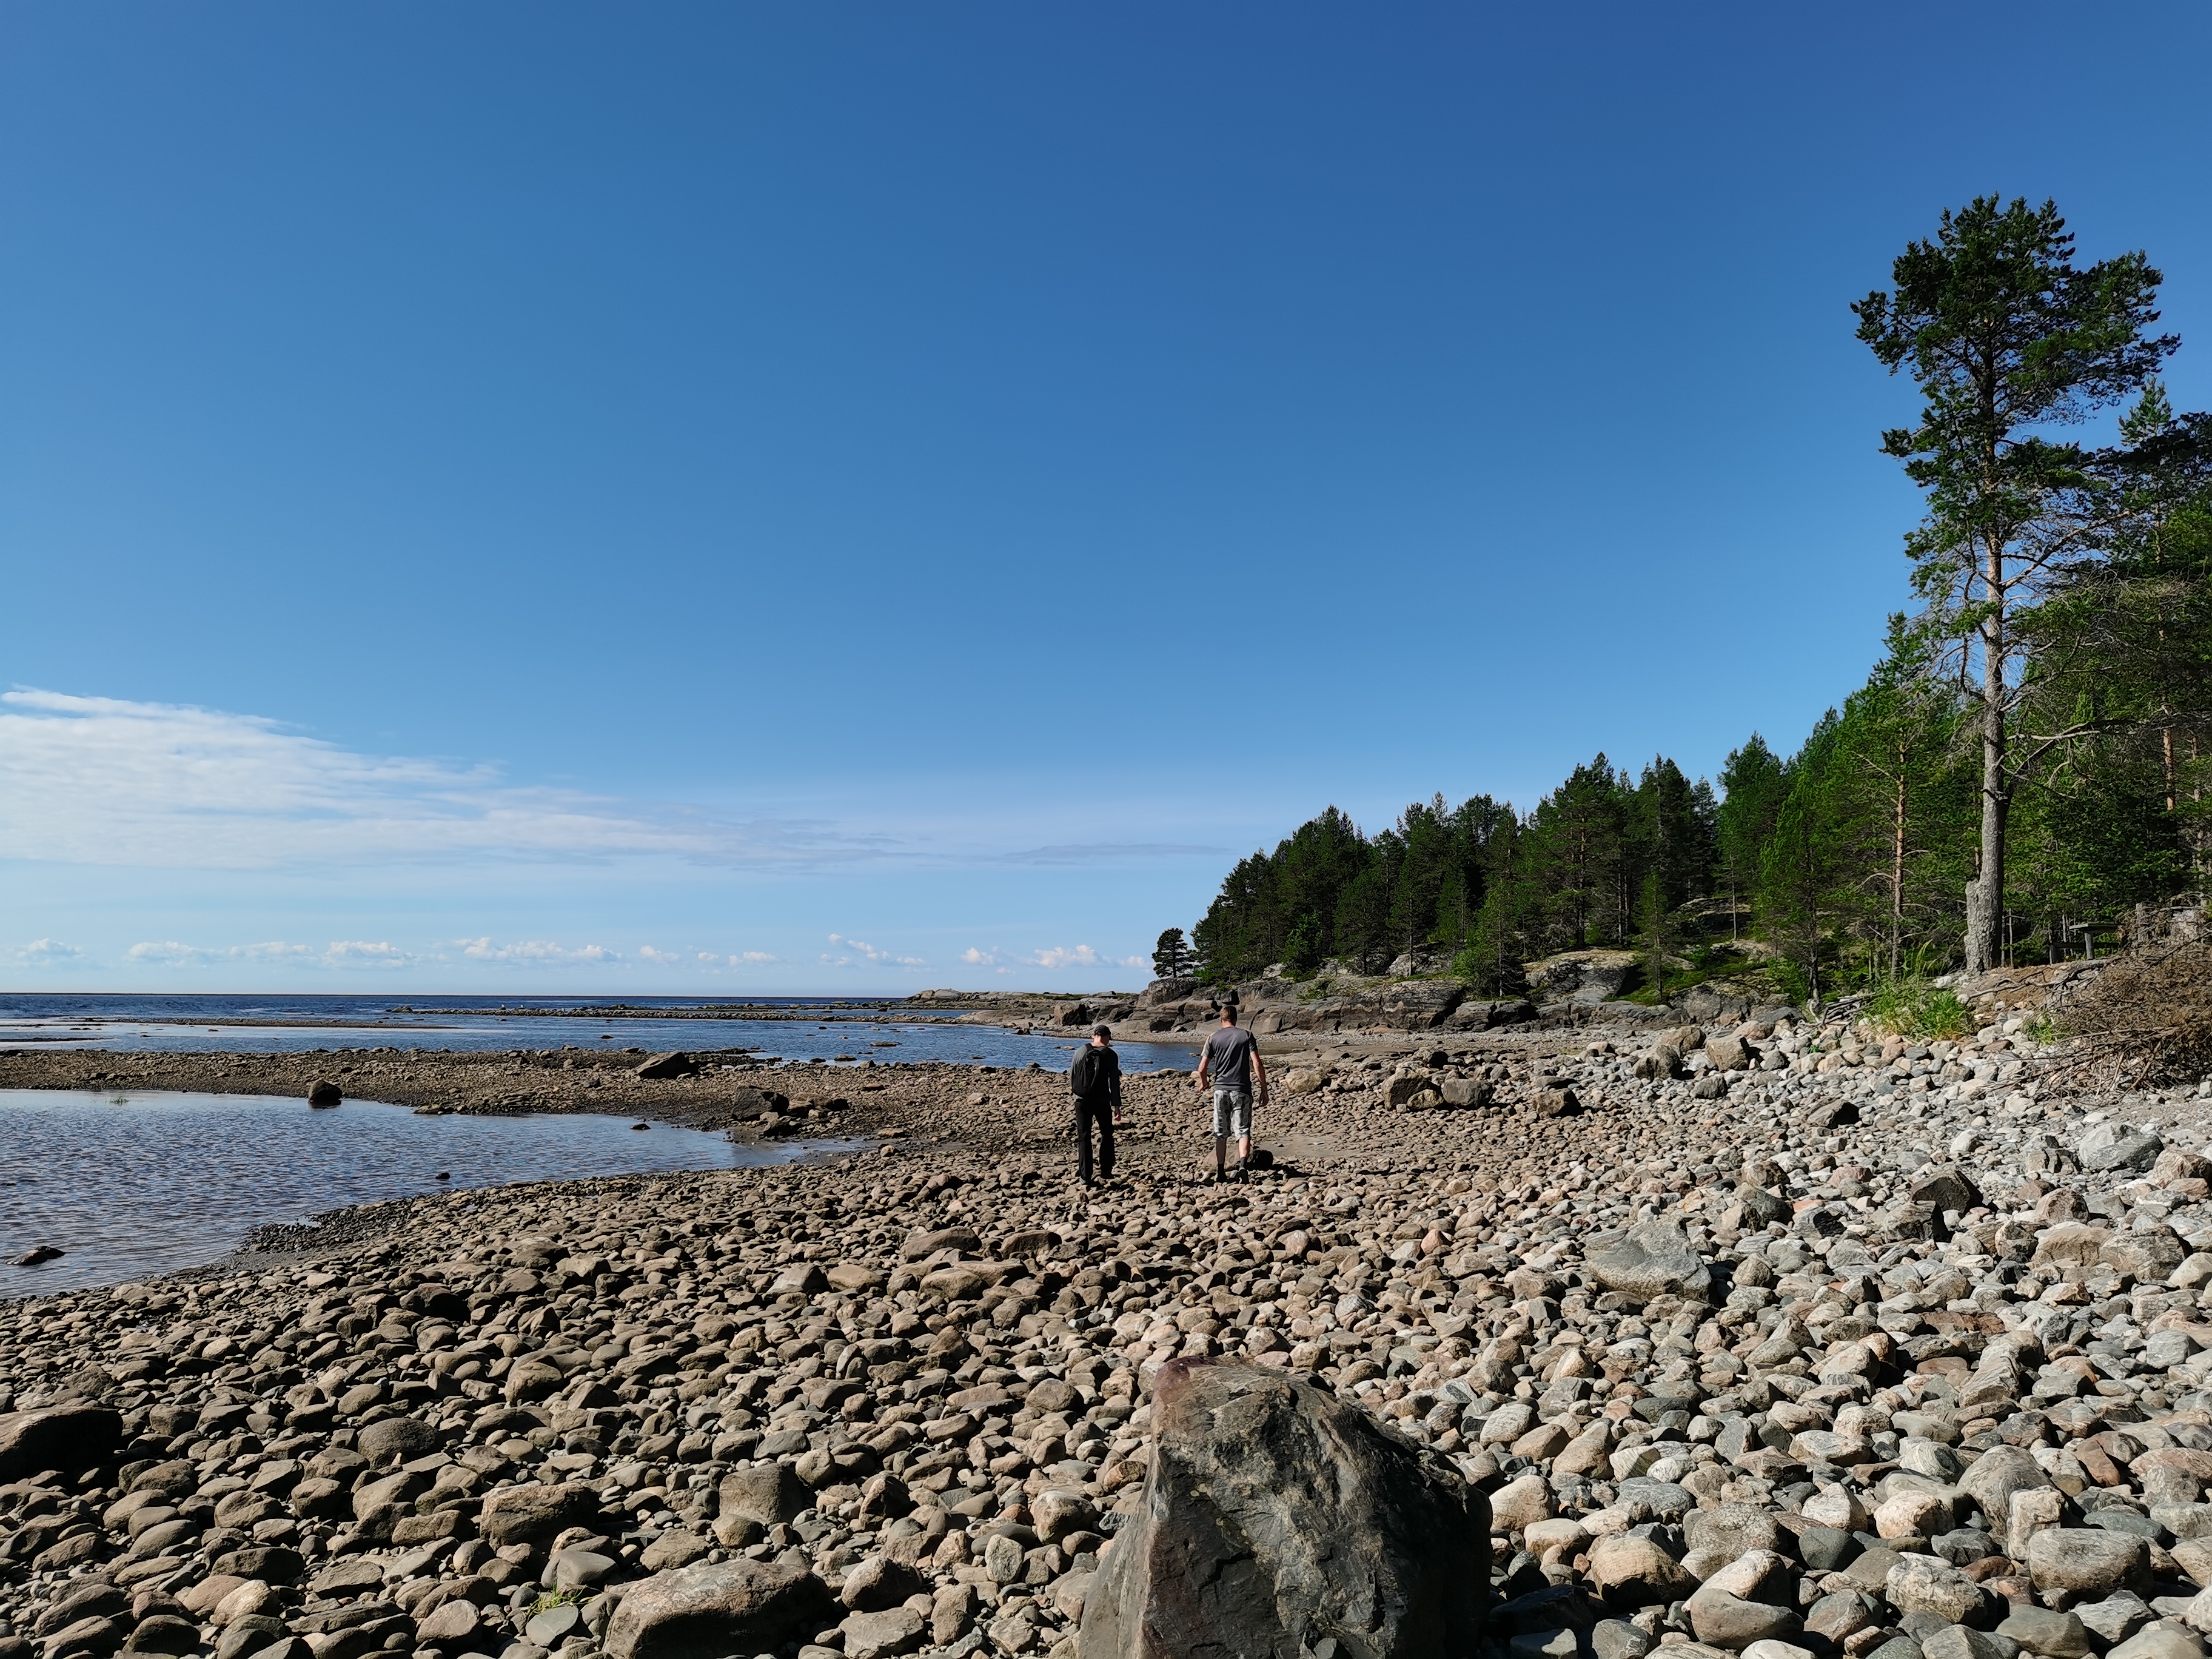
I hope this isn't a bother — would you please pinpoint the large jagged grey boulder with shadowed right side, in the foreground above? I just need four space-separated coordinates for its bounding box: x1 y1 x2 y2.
1084 1361 1491 1659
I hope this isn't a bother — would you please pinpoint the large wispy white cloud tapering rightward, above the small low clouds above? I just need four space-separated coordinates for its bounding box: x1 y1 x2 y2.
0 690 891 870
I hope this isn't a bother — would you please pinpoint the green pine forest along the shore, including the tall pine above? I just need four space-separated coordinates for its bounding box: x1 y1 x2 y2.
1192 197 2212 996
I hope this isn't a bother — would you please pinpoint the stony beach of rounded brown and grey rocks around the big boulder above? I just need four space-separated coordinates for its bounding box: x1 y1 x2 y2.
13 1017 2212 1659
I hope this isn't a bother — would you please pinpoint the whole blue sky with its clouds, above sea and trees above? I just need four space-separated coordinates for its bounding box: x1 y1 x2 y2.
0 0 2212 993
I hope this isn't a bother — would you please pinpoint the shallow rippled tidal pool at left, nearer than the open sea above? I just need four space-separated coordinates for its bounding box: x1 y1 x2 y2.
0 1088 845 1298
